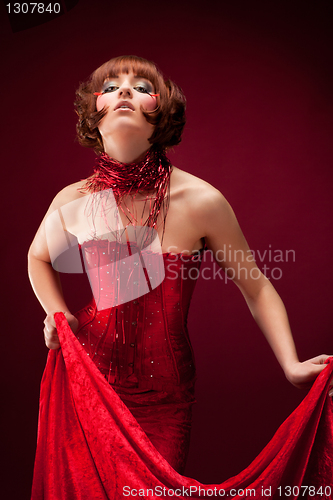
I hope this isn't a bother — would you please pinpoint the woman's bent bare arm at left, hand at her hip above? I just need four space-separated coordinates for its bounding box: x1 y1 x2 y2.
28 188 78 349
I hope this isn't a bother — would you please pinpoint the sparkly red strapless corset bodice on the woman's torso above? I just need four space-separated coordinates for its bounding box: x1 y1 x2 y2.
76 240 205 392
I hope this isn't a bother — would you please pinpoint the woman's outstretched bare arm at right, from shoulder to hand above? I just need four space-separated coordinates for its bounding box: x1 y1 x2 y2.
196 188 333 395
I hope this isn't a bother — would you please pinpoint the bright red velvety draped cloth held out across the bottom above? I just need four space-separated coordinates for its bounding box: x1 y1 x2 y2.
32 313 333 500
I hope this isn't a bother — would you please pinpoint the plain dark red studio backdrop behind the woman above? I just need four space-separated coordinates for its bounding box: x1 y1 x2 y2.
1 0 333 500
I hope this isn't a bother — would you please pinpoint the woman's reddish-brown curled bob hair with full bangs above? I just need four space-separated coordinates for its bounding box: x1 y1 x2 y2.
74 56 186 153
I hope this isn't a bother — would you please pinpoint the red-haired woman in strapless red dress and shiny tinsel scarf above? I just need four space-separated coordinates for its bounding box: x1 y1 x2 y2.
29 56 333 498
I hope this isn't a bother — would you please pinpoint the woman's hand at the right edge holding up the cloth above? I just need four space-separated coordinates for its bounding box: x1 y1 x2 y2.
286 354 333 396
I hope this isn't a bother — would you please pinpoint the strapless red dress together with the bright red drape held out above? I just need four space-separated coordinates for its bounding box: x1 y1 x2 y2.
32 242 333 500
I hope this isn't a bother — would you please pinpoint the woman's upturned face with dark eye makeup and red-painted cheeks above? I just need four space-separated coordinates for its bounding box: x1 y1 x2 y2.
96 72 157 139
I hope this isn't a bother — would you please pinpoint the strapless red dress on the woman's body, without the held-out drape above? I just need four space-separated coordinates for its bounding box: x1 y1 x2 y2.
76 240 204 472
